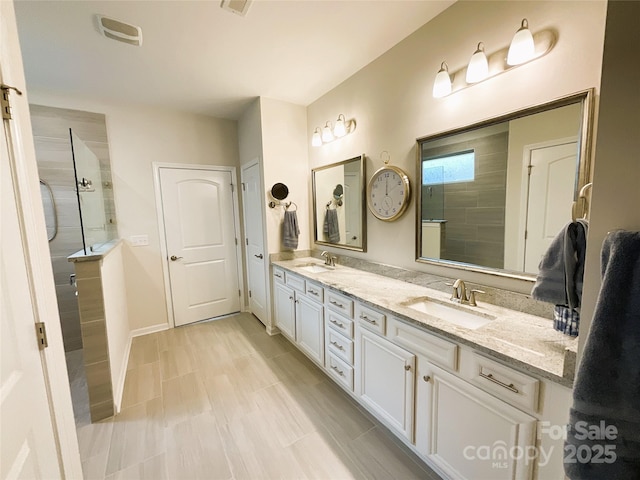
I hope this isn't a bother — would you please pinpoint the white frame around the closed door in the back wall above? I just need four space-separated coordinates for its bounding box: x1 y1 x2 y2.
152 162 244 328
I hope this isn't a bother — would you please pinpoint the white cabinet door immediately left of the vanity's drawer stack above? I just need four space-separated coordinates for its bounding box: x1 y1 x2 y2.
296 295 324 365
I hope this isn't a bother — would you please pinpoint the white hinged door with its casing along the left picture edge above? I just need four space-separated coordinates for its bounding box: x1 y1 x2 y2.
0 2 82 478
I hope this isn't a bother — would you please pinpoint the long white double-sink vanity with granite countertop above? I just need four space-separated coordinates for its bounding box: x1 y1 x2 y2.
272 257 576 480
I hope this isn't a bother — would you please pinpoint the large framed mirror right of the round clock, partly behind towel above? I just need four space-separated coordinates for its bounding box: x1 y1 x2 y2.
416 90 593 281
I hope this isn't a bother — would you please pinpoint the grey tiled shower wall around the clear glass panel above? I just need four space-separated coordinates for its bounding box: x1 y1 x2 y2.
30 105 116 352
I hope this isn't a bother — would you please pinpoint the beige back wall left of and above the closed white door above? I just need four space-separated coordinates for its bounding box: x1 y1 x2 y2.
29 91 239 330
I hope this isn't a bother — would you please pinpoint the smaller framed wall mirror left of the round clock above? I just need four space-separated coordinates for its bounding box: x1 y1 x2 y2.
311 154 367 252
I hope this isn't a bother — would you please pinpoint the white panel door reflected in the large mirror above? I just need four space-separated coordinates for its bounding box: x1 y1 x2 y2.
524 142 578 272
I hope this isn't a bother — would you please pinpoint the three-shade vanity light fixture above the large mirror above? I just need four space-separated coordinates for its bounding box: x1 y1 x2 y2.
433 18 556 98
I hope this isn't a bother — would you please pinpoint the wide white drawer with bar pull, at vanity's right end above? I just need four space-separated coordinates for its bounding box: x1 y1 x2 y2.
460 350 540 411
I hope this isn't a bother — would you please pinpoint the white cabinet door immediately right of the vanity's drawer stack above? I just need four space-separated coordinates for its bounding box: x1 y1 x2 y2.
355 328 416 442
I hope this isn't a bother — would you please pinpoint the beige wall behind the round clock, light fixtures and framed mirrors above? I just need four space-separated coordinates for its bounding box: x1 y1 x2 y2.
307 1 606 293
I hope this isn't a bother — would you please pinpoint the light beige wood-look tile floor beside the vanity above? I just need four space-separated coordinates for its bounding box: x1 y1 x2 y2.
78 314 439 480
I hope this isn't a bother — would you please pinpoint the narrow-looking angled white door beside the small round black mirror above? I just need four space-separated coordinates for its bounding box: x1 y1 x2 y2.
242 162 269 325
